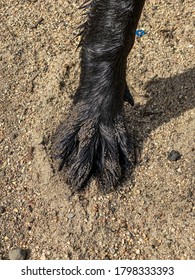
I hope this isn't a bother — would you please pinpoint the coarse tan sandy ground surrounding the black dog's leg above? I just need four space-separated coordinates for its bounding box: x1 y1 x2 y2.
0 0 195 259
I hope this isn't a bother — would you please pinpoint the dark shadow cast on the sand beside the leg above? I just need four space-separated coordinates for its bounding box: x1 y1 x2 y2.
126 68 195 151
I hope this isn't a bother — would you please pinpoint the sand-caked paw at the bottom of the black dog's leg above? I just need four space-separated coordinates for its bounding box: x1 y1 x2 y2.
53 106 135 190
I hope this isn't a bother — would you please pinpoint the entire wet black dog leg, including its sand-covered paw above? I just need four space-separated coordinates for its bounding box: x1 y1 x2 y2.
52 0 145 190
